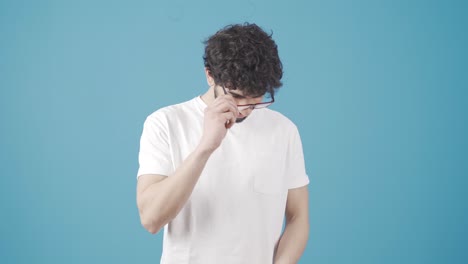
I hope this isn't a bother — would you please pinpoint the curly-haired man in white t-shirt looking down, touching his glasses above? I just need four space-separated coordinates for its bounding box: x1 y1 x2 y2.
137 24 309 264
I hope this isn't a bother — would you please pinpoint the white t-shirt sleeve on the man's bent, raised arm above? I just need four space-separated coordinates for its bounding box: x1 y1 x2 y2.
137 113 173 178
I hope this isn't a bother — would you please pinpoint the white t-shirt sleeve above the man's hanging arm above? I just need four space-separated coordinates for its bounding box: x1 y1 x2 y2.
287 127 309 189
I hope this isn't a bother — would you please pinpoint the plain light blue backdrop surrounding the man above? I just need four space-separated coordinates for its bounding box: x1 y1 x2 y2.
0 0 468 264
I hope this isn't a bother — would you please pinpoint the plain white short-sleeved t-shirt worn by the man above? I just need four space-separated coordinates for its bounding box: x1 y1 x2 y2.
138 97 309 264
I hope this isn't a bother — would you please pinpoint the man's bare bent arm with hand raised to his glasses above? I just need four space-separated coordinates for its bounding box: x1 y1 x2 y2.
137 92 239 234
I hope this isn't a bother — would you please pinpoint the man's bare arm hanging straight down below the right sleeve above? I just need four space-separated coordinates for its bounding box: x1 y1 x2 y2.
274 186 309 264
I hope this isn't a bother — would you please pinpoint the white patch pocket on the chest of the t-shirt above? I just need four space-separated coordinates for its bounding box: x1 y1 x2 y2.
250 152 287 195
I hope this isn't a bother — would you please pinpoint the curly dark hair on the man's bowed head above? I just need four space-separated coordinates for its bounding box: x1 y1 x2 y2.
203 23 283 97
